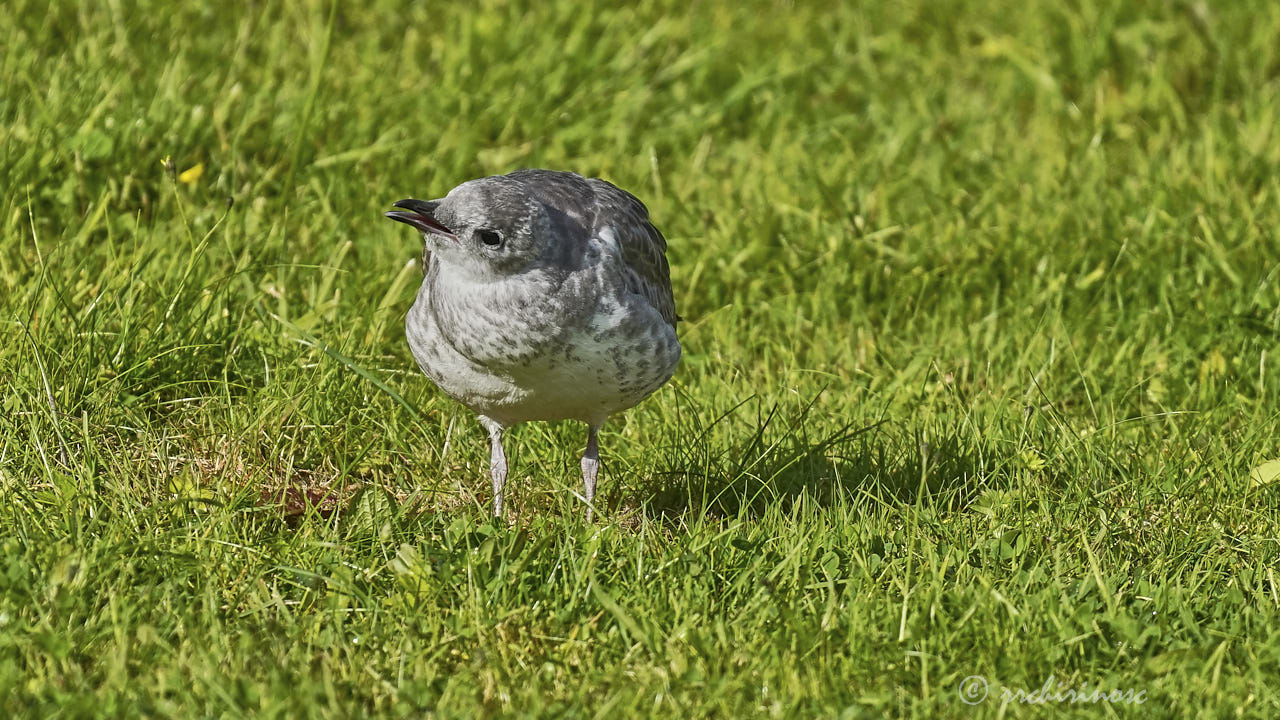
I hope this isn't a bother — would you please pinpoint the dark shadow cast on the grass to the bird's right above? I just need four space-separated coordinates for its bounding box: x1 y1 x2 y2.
636 389 1000 519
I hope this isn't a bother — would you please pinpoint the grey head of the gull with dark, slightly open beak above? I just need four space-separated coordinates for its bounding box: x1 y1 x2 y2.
387 177 552 281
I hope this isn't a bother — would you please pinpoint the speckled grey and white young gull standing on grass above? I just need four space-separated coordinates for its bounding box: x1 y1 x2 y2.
385 169 681 521
